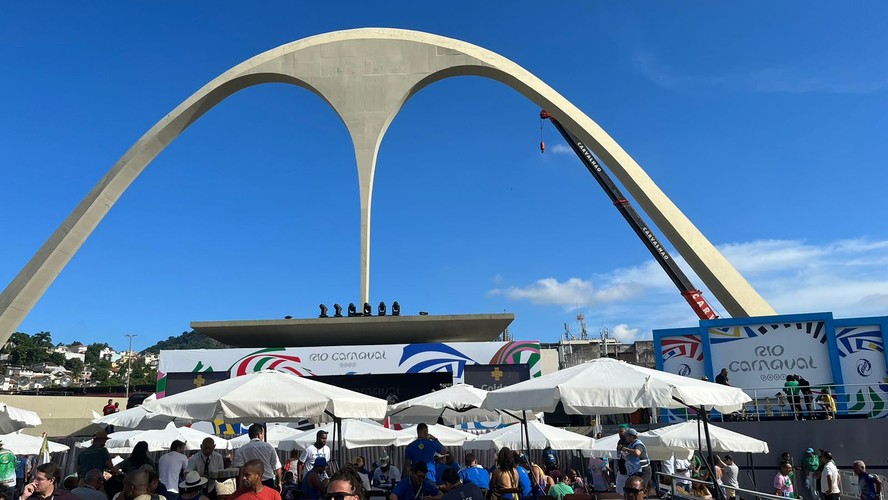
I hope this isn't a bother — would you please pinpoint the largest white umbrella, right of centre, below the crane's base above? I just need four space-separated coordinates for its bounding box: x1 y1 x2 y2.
482 358 751 415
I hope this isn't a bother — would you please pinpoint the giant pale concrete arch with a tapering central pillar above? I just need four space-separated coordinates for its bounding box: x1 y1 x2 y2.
0 28 775 341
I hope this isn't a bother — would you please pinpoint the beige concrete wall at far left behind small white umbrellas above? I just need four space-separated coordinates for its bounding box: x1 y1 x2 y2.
3 395 109 437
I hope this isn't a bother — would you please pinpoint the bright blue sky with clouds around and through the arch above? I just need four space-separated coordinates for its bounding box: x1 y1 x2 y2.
0 1 888 348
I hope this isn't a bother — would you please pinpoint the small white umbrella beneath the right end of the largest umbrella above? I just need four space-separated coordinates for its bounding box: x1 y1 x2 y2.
638 421 768 453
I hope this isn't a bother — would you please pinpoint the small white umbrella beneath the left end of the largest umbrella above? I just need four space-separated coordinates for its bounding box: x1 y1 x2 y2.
463 422 595 451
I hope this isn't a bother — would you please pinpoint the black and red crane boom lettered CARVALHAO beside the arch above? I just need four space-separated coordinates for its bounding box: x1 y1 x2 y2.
540 110 718 319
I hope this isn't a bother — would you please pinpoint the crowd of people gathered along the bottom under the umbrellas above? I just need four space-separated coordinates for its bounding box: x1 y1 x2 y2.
0 424 882 500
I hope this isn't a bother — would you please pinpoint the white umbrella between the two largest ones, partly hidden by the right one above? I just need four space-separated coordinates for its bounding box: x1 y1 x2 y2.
388 384 536 425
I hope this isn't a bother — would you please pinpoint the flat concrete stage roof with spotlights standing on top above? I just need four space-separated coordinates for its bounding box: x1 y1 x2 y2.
191 313 515 347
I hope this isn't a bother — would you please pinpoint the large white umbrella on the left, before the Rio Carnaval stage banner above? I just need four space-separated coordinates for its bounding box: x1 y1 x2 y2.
143 370 387 423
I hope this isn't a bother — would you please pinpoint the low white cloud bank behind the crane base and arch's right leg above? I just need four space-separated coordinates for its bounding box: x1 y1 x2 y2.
490 238 888 340
